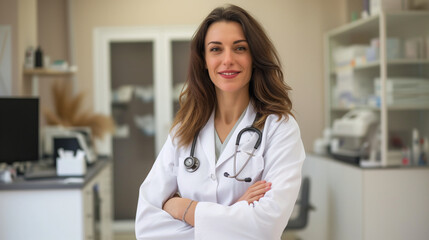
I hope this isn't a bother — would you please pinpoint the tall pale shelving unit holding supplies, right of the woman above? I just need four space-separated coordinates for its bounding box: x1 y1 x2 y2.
325 11 429 166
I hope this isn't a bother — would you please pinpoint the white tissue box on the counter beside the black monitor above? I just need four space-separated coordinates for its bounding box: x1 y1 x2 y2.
57 151 86 176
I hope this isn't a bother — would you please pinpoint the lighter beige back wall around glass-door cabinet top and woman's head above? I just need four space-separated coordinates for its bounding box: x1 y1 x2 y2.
70 0 345 150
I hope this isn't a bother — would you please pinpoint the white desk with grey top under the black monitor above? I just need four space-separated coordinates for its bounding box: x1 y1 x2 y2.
0 159 113 240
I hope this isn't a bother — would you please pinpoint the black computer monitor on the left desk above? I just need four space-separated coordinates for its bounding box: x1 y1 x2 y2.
0 97 39 164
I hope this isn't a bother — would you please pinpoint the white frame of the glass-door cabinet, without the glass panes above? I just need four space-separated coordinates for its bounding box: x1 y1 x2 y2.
93 26 196 155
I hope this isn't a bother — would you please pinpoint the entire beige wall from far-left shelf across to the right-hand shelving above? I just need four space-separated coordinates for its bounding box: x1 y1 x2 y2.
0 0 355 150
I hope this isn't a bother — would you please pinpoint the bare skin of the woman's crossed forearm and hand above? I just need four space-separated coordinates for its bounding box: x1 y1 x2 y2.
162 181 271 226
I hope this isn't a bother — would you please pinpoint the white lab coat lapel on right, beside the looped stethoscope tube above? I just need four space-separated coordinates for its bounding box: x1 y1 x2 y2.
216 103 256 167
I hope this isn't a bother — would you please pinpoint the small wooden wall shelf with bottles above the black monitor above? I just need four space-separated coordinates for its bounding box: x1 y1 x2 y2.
24 68 76 96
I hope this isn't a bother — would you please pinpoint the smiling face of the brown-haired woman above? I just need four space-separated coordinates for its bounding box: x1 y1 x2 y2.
204 21 252 94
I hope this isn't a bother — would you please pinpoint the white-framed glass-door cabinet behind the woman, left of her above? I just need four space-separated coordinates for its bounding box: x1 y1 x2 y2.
94 26 196 221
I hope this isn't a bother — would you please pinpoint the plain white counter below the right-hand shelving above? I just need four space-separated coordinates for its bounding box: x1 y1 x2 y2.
296 154 429 240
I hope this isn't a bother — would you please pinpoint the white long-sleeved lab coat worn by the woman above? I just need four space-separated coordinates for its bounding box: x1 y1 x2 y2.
135 104 305 240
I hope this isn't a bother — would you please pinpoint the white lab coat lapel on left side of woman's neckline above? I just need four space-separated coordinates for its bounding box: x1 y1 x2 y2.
197 111 216 169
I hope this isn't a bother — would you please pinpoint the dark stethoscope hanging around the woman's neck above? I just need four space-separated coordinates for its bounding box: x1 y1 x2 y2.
183 114 262 182
